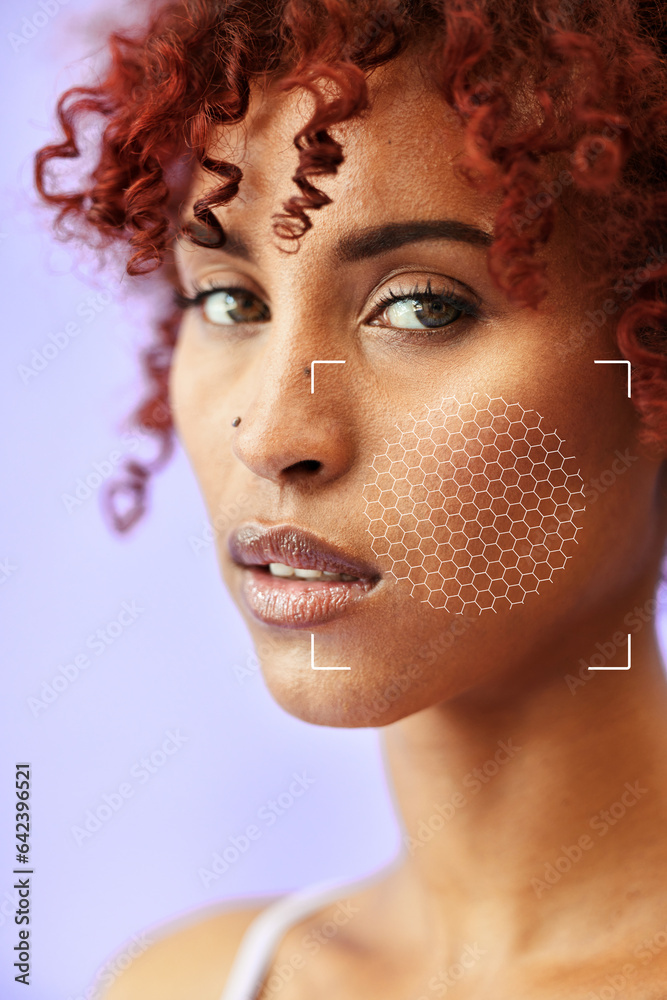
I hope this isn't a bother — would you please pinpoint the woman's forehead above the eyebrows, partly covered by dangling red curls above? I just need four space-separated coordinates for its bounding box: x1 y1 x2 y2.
186 53 501 239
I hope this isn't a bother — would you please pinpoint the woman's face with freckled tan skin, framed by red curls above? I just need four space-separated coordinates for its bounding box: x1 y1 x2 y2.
171 50 664 726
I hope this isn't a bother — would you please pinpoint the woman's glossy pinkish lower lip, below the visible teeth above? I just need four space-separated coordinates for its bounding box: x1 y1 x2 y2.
241 566 374 628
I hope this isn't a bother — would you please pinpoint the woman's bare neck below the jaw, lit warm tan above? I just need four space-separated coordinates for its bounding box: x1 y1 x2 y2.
384 608 667 962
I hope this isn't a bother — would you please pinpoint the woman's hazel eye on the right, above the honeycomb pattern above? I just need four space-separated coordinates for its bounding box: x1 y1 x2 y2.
371 279 480 331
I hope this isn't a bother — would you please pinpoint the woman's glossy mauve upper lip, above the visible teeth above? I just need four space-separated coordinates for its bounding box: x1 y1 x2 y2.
228 524 380 580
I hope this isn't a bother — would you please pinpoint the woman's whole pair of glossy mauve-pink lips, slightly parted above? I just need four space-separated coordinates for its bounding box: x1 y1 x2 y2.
228 524 381 628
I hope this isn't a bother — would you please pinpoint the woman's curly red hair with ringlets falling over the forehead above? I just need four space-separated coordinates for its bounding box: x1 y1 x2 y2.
35 0 667 530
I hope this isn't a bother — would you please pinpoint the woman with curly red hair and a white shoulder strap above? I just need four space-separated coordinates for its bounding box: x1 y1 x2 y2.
37 0 667 1000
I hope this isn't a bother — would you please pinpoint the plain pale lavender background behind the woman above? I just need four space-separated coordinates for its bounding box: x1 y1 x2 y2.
0 0 667 1000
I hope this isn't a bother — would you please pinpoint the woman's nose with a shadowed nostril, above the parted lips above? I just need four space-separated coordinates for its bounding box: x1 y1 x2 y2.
232 338 354 489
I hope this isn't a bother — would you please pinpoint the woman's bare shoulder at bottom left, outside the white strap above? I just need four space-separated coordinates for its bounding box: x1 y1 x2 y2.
95 897 276 1000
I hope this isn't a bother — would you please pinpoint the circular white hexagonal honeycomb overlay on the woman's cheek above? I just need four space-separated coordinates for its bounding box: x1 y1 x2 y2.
363 393 584 614
